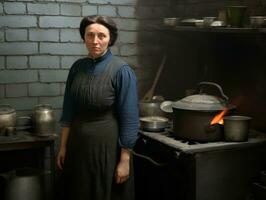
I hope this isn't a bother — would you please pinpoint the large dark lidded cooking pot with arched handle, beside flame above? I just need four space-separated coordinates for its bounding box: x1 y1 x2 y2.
172 82 234 142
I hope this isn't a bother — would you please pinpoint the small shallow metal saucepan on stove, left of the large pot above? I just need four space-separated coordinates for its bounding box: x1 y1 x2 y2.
140 116 169 132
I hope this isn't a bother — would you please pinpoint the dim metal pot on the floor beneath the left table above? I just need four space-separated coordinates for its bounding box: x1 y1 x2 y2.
0 168 44 200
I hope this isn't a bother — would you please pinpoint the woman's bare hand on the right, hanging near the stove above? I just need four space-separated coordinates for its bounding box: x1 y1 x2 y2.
115 160 130 184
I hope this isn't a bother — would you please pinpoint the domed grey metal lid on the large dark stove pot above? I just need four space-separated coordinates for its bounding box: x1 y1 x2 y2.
172 94 227 111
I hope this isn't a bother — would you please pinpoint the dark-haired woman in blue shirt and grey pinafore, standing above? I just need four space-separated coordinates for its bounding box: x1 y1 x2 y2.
57 16 138 200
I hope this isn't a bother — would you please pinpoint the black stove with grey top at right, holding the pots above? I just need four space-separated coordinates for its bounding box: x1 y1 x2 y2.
135 130 266 200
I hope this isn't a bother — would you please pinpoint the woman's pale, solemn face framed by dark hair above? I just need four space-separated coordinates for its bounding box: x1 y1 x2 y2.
84 23 110 58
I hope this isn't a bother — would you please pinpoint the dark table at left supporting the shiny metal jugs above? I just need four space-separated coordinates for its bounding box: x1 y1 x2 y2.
0 131 57 199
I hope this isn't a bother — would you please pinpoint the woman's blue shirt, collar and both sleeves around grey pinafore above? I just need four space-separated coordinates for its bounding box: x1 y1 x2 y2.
60 50 139 149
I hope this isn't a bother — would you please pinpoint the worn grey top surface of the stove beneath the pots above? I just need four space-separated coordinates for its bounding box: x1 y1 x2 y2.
140 130 266 153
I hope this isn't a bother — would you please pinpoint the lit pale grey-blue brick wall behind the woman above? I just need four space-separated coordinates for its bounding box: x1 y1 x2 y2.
0 0 141 111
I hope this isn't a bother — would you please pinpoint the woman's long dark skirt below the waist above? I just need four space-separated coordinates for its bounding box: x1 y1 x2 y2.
63 114 134 200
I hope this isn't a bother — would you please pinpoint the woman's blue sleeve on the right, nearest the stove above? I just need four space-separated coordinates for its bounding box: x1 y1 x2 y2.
115 65 139 149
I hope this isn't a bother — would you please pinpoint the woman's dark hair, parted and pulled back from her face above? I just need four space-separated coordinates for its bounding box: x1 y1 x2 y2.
79 15 117 47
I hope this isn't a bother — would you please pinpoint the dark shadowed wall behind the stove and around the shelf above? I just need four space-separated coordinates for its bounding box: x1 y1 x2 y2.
138 0 266 131
